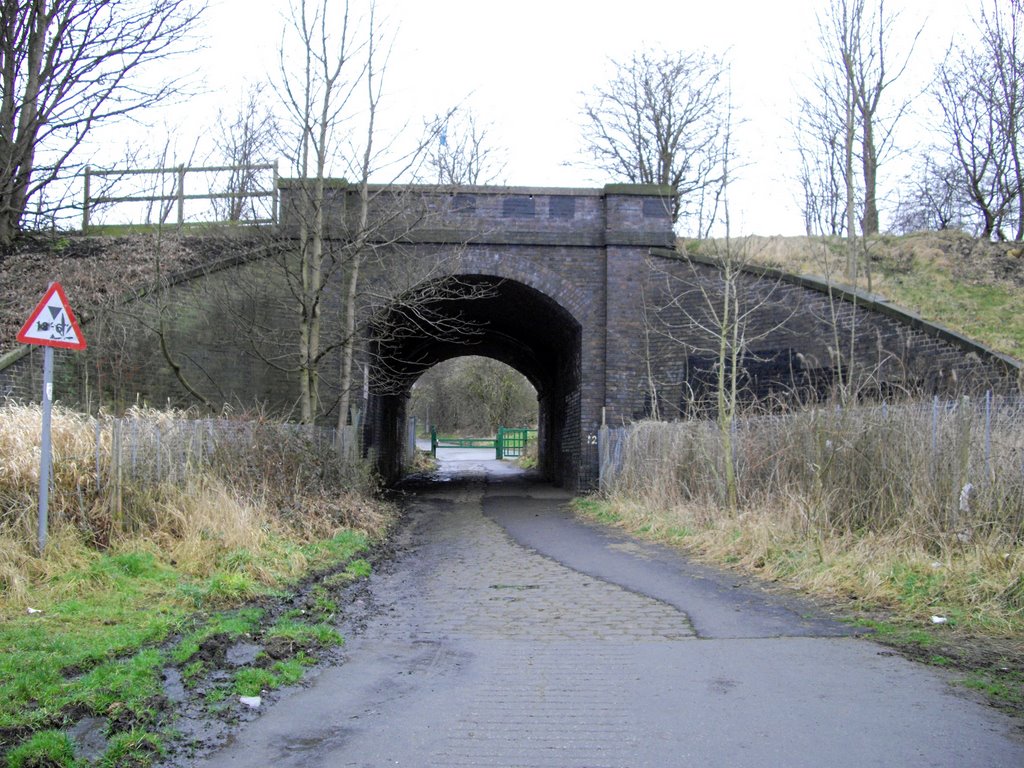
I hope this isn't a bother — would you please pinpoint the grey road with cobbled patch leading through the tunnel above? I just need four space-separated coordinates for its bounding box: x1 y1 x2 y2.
188 452 1024 768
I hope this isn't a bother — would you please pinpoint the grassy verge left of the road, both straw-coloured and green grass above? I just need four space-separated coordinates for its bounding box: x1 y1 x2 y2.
0 406 390 766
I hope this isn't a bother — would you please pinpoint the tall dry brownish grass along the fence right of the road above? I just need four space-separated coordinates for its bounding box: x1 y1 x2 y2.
605 401 1024 628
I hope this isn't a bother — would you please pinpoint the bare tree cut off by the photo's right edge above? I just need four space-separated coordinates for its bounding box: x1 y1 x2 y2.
933 2 1024 240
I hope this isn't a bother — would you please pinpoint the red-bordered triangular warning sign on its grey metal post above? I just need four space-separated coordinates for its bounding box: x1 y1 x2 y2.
17 283 85 552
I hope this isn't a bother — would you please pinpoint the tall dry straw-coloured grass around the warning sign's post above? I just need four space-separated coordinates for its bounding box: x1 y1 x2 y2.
0 403 388 604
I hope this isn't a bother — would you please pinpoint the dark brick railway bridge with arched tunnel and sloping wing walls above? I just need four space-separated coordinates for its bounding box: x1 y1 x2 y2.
4 180 1020 487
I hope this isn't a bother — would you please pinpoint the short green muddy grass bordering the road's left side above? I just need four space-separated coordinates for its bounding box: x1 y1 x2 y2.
0 531 380 766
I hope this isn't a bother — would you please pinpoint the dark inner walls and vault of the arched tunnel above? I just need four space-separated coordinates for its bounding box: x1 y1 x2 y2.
365 274 582 484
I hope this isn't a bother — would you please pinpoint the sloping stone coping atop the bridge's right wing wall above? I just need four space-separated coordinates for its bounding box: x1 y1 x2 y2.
650 248 1024 386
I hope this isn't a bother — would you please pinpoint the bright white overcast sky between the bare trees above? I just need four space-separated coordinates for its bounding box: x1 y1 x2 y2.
149 0 975 234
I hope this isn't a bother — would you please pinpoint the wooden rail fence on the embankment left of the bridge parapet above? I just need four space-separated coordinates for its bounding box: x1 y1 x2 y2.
82 162 279 232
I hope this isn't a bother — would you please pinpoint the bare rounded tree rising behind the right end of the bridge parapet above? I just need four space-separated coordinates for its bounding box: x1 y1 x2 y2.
584 51 728 234
